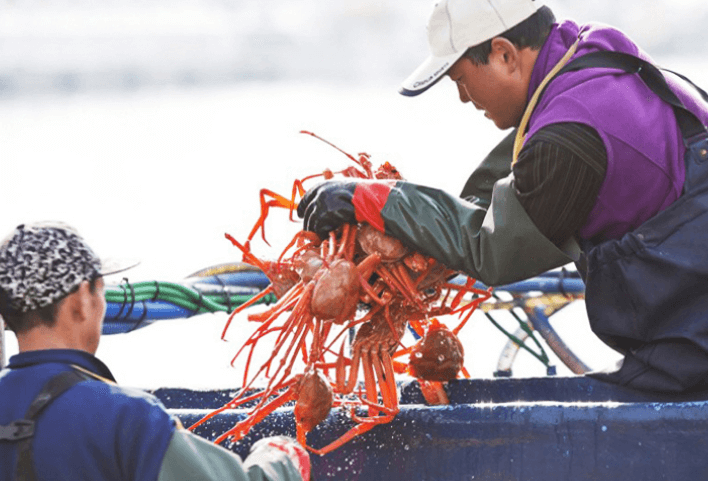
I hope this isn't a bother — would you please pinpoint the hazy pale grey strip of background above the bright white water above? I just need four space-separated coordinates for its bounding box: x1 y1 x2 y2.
0 0 708 98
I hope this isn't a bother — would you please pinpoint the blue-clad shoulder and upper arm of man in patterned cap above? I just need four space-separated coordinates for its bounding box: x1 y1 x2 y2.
35 378 176 479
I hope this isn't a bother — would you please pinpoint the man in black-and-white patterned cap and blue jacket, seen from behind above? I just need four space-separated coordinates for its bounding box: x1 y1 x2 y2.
0 223 310 481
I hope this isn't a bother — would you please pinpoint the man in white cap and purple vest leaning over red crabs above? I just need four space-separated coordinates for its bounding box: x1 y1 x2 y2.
298 0 708 392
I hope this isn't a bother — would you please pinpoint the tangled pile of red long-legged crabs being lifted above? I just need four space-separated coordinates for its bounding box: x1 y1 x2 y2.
185 132 490 454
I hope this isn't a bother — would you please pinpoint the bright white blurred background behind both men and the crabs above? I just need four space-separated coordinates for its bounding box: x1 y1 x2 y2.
0 0 708 387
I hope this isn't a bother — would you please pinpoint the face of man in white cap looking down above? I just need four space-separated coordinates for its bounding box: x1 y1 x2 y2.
447 49 526 130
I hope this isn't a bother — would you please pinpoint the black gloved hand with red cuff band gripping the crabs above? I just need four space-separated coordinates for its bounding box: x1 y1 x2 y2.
297 179 396 239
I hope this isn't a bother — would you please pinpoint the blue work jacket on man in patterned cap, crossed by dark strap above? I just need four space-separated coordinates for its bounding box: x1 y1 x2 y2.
0 349 175 481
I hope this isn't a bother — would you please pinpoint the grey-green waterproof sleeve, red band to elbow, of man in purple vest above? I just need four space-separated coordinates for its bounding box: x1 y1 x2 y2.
381 175 579 286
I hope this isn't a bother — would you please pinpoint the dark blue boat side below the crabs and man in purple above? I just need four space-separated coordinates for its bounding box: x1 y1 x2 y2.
155 377 708 481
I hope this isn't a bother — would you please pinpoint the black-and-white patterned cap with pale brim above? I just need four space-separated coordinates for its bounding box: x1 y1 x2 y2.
0 222 137 312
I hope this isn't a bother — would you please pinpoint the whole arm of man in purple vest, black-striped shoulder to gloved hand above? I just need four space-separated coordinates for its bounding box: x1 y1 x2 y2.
298 124 606 285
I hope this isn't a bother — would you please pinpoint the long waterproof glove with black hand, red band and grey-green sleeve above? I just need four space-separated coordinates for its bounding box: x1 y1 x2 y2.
297 176 576 286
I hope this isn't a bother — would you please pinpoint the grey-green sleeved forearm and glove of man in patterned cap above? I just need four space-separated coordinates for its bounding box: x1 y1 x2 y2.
158 429 309 481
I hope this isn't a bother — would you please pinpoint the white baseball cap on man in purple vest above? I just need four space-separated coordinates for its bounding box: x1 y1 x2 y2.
399 0 543 97
